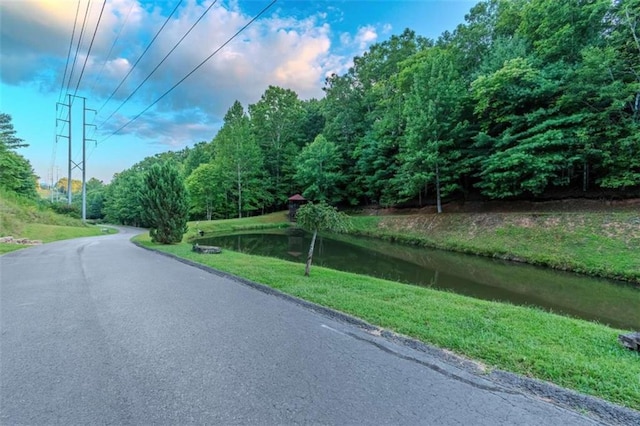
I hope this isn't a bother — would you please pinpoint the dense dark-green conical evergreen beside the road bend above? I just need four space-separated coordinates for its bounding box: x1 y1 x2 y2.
140 162 189 244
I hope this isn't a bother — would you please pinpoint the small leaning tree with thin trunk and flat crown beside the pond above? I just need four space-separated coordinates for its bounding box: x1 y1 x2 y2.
296 201 348 277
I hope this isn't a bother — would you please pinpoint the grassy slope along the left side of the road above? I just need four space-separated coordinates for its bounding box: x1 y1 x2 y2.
0 191 109 254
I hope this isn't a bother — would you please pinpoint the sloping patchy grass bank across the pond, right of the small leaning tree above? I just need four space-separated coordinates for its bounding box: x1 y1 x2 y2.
352 212 640 283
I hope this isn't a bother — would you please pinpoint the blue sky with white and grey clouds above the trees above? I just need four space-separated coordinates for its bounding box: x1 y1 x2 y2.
0 0 477 182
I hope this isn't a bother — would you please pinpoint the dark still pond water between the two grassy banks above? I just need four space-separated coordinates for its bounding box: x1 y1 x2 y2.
198 229 640 330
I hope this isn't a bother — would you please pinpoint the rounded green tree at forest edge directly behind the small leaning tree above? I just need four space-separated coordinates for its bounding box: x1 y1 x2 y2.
295 135 343 203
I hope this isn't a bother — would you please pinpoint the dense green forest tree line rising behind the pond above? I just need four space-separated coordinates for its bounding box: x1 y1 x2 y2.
5 0 640 225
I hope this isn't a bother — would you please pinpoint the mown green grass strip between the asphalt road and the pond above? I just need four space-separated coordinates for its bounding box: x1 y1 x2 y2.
138 236 640 409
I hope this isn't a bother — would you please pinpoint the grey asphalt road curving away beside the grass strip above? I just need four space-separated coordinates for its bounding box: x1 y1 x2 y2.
0 228 636 426
